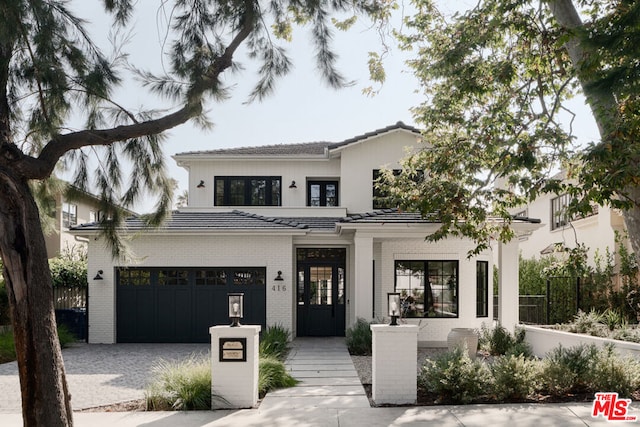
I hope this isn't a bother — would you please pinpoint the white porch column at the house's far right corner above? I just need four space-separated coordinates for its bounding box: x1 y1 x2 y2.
498 238 520 333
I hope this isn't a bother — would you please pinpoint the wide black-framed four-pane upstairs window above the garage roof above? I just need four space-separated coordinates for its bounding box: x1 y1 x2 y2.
214 176 282 206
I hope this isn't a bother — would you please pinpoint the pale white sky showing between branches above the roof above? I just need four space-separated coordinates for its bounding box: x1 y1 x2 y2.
73 0 597 212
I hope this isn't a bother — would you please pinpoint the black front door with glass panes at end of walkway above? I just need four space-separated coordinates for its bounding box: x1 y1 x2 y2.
297 249 346 336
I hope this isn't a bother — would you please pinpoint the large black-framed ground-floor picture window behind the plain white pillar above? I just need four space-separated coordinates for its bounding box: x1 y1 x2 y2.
395 261 458 317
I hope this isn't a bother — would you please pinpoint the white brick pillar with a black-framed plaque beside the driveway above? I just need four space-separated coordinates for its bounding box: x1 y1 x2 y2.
209 325 261 409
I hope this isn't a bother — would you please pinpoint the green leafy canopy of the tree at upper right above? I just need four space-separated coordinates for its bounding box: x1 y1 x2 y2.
385 0 640 253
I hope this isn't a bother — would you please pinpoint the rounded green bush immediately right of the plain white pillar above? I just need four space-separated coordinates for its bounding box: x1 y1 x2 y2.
418 348 491 403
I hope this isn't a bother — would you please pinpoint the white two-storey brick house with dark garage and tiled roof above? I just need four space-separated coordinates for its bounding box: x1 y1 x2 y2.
74 122 539 345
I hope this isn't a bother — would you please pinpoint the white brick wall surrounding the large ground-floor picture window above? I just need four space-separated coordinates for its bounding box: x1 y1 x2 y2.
375 237 493 346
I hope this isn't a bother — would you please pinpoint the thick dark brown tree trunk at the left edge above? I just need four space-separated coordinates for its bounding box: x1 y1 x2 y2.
0 172 73 427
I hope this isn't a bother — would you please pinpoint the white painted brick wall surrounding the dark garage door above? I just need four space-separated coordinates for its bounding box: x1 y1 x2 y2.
88 233 295 343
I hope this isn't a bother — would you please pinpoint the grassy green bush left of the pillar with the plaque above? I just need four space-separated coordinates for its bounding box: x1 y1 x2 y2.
145 355 211 411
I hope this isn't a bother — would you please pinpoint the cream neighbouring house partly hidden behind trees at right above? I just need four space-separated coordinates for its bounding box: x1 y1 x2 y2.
513 174 630 265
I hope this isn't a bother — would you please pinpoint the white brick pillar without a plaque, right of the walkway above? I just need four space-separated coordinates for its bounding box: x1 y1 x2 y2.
371 325 418 405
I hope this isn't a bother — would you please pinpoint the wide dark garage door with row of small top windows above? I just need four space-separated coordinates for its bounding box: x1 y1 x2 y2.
116 267 267 343
